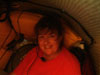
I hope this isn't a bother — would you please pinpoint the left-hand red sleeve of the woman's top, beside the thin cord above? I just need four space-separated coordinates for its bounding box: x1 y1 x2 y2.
10 48 35 75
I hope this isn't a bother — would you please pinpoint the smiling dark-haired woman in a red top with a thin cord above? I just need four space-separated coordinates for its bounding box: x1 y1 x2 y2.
11 15 81 75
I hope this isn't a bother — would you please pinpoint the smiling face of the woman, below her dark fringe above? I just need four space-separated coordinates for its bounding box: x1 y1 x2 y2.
38 30 61 56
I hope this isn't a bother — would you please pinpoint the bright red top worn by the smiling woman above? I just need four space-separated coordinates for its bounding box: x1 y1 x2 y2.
10 47 81 75
